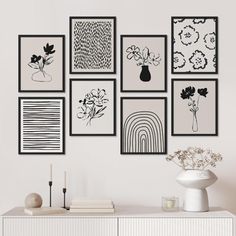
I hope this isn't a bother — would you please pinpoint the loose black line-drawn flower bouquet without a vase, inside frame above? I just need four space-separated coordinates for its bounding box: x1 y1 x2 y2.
77 88 109 126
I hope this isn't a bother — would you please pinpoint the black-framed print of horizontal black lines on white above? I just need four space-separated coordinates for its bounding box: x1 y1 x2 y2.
19 97 65 154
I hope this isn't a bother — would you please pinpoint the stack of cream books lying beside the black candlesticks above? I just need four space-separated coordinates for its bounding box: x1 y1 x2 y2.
70 199 115 213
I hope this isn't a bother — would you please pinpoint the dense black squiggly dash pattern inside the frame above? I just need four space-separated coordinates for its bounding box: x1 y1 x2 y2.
73 21 112 70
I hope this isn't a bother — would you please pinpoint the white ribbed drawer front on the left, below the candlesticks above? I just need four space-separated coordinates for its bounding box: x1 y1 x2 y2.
3 217 117 236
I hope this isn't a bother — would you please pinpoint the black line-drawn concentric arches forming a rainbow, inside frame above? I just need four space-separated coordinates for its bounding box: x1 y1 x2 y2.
124 111 165 153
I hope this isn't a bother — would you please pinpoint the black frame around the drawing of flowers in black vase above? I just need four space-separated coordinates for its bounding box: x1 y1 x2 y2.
120 34 168 93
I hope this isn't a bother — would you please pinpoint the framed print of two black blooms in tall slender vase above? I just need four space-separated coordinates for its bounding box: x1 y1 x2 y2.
172 79 218 136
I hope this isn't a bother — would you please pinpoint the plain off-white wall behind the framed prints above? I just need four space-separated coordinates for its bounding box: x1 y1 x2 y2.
0 0 236 216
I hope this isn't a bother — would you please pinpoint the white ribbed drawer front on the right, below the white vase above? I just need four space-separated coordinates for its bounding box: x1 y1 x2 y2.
119 218 233 236
